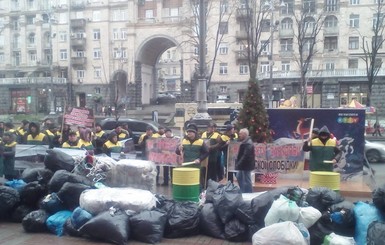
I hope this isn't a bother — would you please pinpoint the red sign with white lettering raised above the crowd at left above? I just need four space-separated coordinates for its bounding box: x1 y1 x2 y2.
63 107 95 128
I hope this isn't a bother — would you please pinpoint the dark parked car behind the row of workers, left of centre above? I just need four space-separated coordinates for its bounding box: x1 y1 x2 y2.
100 117 159 147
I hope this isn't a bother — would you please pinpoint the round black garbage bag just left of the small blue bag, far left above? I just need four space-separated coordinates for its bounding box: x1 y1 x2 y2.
19 181 48 209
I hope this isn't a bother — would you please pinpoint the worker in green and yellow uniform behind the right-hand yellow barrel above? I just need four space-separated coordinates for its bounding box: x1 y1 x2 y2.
302 126 342 172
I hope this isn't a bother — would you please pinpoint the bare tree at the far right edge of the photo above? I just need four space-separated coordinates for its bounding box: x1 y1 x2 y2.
361 0 385 106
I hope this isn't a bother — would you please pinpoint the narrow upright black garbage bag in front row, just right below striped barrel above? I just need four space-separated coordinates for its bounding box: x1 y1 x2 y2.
199 203 225 240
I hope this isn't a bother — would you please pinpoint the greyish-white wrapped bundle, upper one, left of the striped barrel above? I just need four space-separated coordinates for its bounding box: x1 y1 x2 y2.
105 159 156 193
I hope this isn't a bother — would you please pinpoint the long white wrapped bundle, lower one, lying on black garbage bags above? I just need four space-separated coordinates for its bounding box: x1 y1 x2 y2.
79 187 156 215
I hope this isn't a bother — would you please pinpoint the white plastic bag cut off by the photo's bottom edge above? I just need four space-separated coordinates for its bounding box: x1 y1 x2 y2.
252 221 308 245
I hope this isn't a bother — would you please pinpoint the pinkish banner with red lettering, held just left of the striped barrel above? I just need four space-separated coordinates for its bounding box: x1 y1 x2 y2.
146 138 182 166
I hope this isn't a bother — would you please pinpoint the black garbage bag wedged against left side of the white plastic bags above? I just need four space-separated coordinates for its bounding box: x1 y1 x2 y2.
251 187 289 227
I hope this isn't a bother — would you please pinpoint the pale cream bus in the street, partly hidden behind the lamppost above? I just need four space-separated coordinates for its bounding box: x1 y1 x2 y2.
174 103 242 127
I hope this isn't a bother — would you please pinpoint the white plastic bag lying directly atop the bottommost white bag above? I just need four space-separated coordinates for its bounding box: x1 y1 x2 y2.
265 195 299 226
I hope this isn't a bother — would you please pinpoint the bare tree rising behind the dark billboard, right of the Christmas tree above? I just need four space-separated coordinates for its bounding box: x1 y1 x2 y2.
292 0 325 108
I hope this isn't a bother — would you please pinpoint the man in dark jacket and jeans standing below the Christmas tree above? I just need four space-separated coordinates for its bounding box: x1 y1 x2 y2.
235 128 255 193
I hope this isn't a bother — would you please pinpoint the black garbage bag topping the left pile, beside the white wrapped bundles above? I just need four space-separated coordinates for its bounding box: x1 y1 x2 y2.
44 149 75 172
